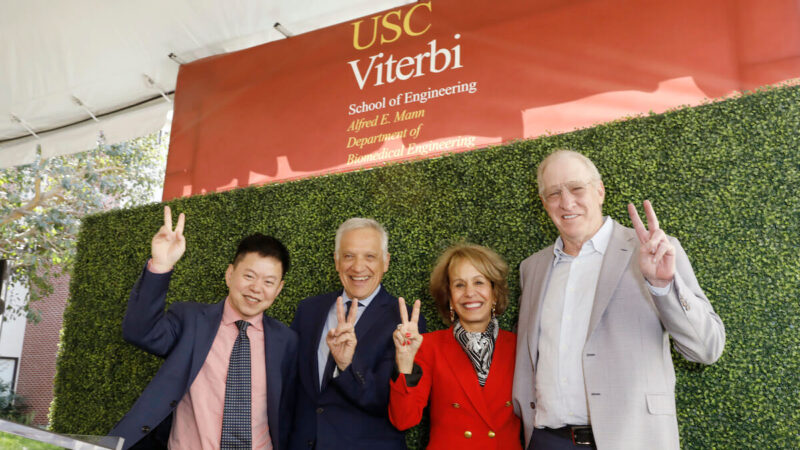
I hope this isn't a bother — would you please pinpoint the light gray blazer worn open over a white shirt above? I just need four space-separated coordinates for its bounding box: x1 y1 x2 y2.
513 221 725 450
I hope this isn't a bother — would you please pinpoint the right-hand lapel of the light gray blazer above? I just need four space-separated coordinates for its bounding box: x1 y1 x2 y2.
586 221 636 342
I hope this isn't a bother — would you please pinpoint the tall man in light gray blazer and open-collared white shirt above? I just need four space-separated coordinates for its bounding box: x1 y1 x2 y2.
513 150 725 450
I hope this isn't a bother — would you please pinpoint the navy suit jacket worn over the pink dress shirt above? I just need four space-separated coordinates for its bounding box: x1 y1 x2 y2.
109 269 297 450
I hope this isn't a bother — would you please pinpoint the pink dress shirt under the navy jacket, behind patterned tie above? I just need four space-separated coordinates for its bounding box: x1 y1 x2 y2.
169 298 272 450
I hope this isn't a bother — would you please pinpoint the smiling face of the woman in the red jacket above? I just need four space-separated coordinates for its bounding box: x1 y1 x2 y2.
448 259 495 333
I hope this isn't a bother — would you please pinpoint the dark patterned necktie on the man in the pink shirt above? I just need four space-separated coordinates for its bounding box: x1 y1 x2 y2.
220 320 253 449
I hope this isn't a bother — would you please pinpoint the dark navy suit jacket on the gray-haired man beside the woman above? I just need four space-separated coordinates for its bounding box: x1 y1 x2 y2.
291 286 425 450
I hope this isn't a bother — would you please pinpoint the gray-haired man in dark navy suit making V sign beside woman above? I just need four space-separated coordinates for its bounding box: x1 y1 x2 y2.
291 218 425 450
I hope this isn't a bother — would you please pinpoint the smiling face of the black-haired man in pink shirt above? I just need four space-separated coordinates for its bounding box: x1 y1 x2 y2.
225 253 283 320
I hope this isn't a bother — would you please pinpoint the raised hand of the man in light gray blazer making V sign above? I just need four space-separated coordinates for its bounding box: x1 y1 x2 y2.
628 200 675 287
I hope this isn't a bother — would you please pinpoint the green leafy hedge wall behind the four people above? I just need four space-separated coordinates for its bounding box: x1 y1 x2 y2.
51 87 800 449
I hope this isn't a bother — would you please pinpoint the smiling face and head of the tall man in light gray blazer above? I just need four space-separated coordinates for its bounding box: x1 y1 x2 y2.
541 156 605 256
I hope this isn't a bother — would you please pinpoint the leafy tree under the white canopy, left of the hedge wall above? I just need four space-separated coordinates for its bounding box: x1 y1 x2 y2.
0 134 167 321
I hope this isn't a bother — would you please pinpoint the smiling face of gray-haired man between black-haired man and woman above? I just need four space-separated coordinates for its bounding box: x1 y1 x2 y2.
334 228 389 300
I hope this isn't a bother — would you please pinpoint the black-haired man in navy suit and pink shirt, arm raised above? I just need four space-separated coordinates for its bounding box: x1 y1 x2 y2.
109 207 297 450
